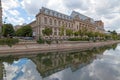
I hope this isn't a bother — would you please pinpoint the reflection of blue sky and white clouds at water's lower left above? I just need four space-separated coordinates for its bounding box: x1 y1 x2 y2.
3 58 41 80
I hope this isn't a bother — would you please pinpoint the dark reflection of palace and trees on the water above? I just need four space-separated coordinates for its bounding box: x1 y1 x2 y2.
0 45 116 80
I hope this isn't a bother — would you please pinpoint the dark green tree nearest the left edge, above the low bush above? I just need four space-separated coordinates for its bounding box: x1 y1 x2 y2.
2 24 15 37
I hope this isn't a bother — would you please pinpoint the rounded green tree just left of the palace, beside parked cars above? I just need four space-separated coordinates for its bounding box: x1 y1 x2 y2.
16 25 33 37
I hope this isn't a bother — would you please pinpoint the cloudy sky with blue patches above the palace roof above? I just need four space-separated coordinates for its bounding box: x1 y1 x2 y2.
2 0 120 33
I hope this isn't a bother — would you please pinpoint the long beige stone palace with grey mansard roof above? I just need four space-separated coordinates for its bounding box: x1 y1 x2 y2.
29 7 105 39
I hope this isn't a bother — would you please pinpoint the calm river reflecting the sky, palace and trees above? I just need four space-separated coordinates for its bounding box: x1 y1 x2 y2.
0 44 120 80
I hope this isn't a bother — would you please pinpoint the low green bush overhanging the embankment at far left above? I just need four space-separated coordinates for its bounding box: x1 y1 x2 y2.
0 38 19 47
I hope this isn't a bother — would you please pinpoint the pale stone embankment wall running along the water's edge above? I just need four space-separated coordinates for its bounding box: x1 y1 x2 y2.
0 41 120 56
